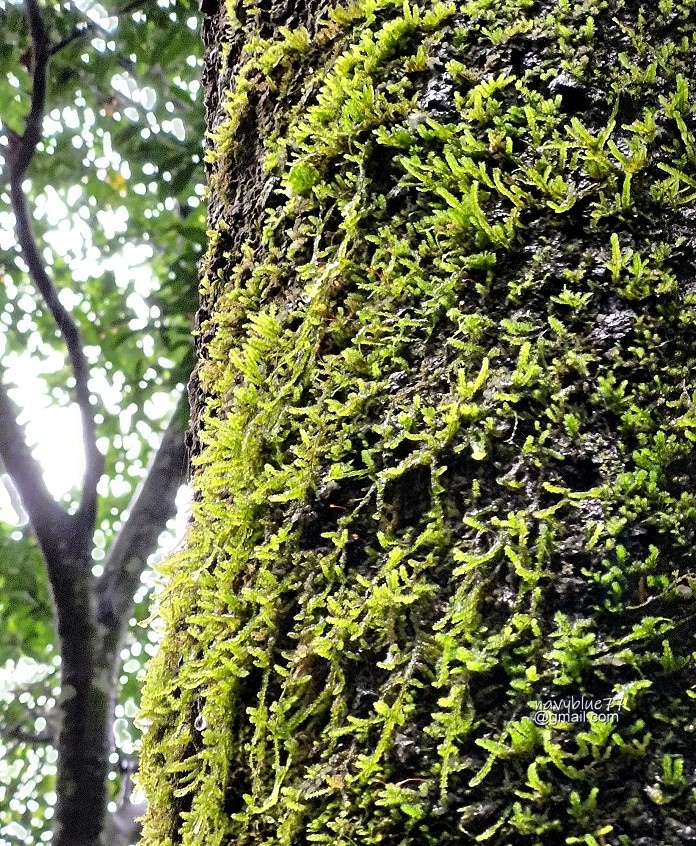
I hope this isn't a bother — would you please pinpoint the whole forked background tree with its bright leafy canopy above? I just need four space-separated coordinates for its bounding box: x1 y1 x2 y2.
0 0 204 846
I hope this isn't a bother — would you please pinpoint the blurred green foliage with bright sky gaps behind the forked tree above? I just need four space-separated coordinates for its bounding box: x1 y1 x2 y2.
0 0 205 843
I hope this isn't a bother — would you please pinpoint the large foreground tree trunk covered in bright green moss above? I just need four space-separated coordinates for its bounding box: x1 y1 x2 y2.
143 0 696 846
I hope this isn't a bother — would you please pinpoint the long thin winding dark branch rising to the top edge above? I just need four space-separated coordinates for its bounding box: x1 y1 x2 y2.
7 0 104 535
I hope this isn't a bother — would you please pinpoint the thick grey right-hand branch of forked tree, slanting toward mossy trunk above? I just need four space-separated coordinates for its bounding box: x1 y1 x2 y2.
98 392 188 646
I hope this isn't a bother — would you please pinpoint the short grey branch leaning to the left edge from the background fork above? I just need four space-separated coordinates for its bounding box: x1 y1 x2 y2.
0 381 68 555
